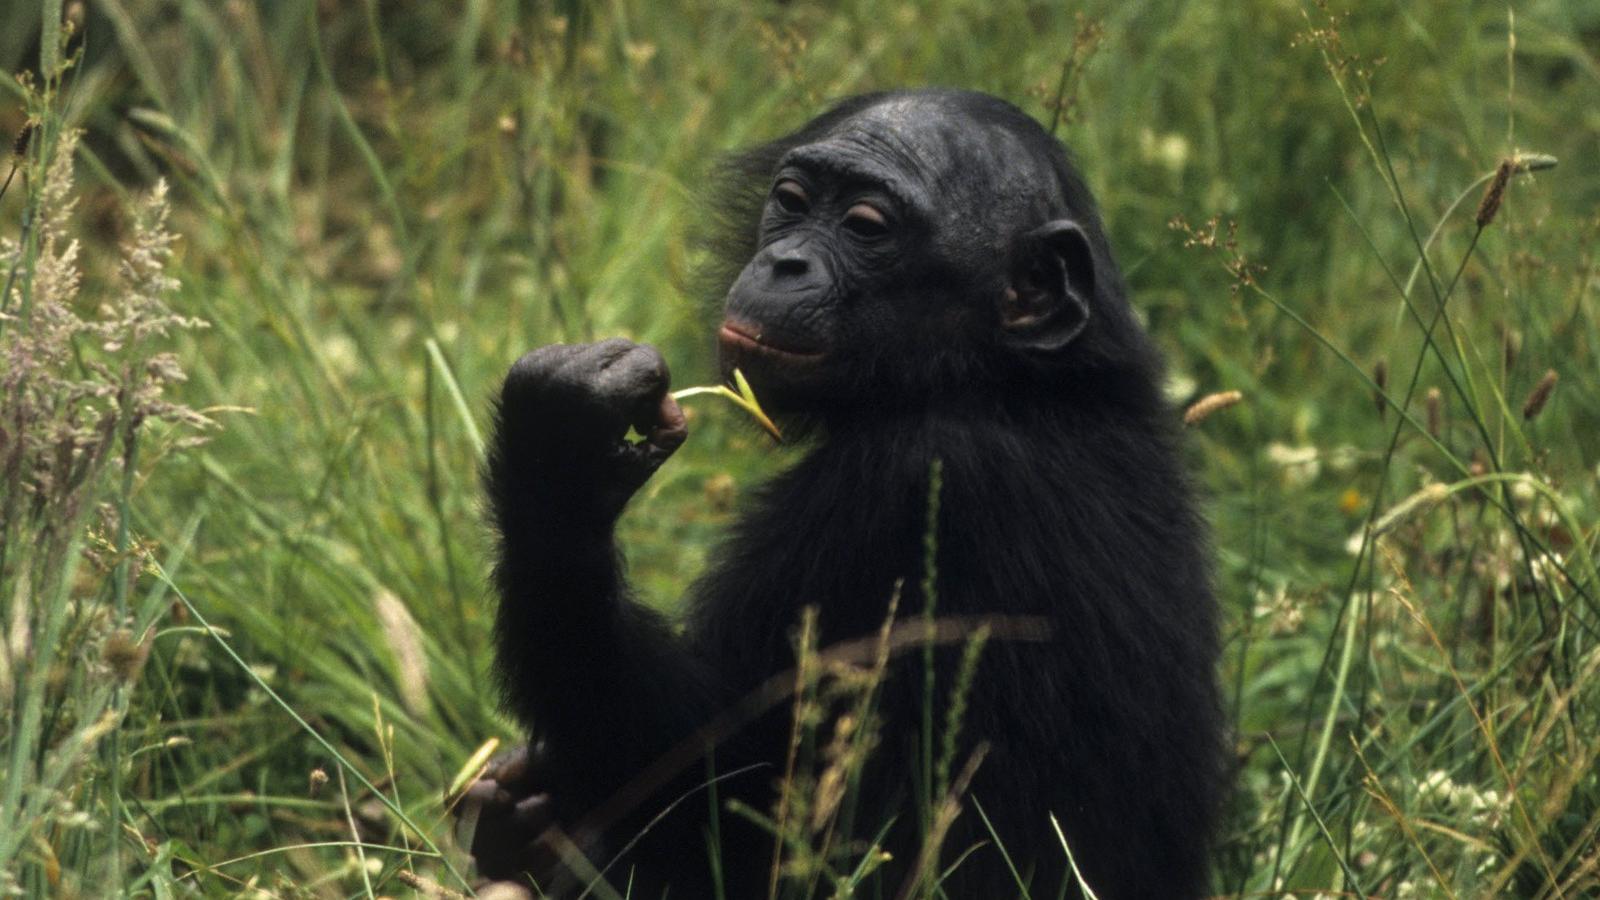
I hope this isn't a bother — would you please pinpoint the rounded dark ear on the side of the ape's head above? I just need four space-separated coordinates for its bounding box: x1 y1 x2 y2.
1000 219 1094 352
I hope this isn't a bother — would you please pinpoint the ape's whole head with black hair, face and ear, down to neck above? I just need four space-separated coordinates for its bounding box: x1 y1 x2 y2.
718 90 1155 412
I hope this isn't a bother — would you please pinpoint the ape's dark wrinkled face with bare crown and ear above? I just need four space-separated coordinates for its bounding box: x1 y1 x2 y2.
718 96 1093 410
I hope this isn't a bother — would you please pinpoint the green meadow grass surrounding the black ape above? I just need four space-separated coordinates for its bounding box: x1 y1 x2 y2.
0 0 1600 897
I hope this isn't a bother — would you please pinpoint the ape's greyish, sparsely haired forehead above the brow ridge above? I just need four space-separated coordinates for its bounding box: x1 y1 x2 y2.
784 96 1054 213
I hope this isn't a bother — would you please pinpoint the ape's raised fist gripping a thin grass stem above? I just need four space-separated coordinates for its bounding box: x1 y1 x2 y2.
499 338 688 516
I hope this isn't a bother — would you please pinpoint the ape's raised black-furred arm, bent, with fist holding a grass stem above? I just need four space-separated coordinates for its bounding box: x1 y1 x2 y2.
486 340 715 818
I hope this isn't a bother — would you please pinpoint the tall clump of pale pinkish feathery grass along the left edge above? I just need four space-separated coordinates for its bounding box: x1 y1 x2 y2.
0 130 211 894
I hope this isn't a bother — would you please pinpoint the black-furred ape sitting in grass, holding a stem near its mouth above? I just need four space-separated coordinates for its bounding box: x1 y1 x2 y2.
474 90 1222 900
